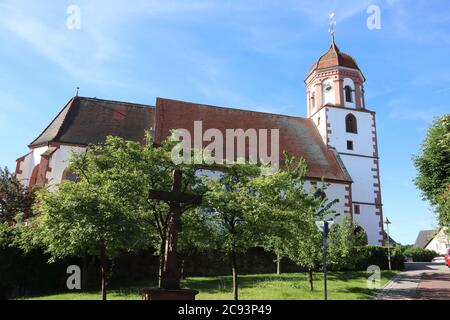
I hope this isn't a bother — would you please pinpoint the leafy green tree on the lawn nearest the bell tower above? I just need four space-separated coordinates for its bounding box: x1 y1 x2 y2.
253 154 337 290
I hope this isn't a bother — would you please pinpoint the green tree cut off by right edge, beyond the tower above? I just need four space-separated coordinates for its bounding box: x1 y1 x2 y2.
414 114 450 226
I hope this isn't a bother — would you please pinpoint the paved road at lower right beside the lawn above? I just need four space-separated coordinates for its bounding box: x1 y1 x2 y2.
375 263 450 300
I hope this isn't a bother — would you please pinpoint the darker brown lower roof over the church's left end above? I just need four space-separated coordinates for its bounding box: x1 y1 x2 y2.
30 97 155 147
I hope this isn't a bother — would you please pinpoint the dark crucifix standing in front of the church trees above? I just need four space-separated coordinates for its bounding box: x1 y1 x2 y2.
149 170 202 290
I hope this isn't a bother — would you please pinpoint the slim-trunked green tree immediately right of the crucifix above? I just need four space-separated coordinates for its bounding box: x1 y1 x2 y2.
203 164 261 300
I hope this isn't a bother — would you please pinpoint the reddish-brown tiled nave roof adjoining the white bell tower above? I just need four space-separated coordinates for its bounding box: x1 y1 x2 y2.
155 98 351 182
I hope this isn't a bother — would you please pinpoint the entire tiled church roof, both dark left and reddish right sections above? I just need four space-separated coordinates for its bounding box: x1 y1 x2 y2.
30 97 351 183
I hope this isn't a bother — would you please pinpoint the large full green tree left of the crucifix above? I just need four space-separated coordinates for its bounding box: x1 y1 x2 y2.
33 137 158 300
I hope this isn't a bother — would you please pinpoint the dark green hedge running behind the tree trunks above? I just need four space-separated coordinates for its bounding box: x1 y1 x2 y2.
0 246 405 299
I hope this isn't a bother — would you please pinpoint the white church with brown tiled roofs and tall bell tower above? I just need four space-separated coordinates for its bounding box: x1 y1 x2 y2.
16 37 384 245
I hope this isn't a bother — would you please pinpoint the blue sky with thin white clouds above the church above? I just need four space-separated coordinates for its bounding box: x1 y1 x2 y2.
0 0 450 243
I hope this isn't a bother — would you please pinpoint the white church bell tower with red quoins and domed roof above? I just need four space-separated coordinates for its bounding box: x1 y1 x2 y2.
305 33 384 245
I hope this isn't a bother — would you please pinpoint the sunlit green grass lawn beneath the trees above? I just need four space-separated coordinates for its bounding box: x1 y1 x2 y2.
24 271 396 300
